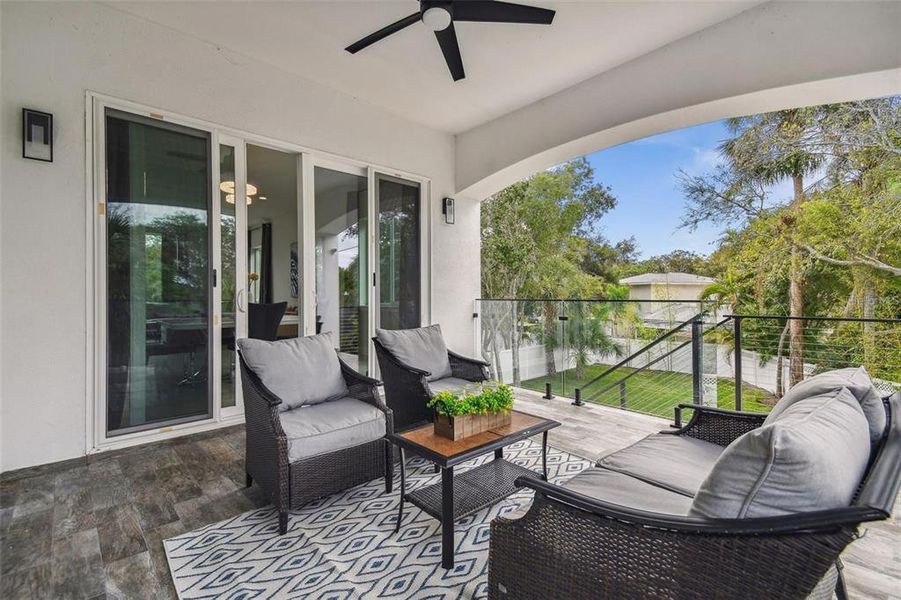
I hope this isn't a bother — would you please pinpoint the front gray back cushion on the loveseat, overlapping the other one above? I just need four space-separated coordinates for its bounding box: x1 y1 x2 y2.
690 388 870 519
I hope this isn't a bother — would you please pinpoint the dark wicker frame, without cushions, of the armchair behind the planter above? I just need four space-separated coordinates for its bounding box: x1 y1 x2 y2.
372 338 489 431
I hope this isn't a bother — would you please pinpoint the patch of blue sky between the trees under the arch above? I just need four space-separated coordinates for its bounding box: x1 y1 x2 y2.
586 121 783 258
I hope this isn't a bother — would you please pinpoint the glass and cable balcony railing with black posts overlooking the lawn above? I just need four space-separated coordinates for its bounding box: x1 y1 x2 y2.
475 300 901 419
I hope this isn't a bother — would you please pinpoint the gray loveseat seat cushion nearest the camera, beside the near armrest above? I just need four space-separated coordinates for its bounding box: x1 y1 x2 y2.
563 467 691 516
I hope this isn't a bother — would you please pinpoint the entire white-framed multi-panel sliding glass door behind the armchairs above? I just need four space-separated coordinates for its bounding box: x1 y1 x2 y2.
91 97 427 448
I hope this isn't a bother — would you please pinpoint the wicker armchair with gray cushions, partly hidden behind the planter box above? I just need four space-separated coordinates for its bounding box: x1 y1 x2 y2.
372 325 489 431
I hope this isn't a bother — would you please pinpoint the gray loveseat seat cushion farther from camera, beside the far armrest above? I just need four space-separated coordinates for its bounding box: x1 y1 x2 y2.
598 433 723 497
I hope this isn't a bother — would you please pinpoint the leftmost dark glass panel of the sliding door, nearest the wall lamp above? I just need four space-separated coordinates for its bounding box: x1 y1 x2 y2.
105 110 212 435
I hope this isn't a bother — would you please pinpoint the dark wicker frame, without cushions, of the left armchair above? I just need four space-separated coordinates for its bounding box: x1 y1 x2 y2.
238 352 394 535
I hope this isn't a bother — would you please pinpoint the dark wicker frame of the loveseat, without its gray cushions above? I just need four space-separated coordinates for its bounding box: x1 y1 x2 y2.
488 394 901 600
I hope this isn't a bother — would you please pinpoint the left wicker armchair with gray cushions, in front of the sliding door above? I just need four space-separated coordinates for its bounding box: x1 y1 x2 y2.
238 334 394 535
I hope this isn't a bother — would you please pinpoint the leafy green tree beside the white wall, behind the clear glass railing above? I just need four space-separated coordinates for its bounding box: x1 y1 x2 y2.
482 158 616 385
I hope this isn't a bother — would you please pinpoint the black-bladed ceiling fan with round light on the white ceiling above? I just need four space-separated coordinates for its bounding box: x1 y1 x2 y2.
345 0 555 81
